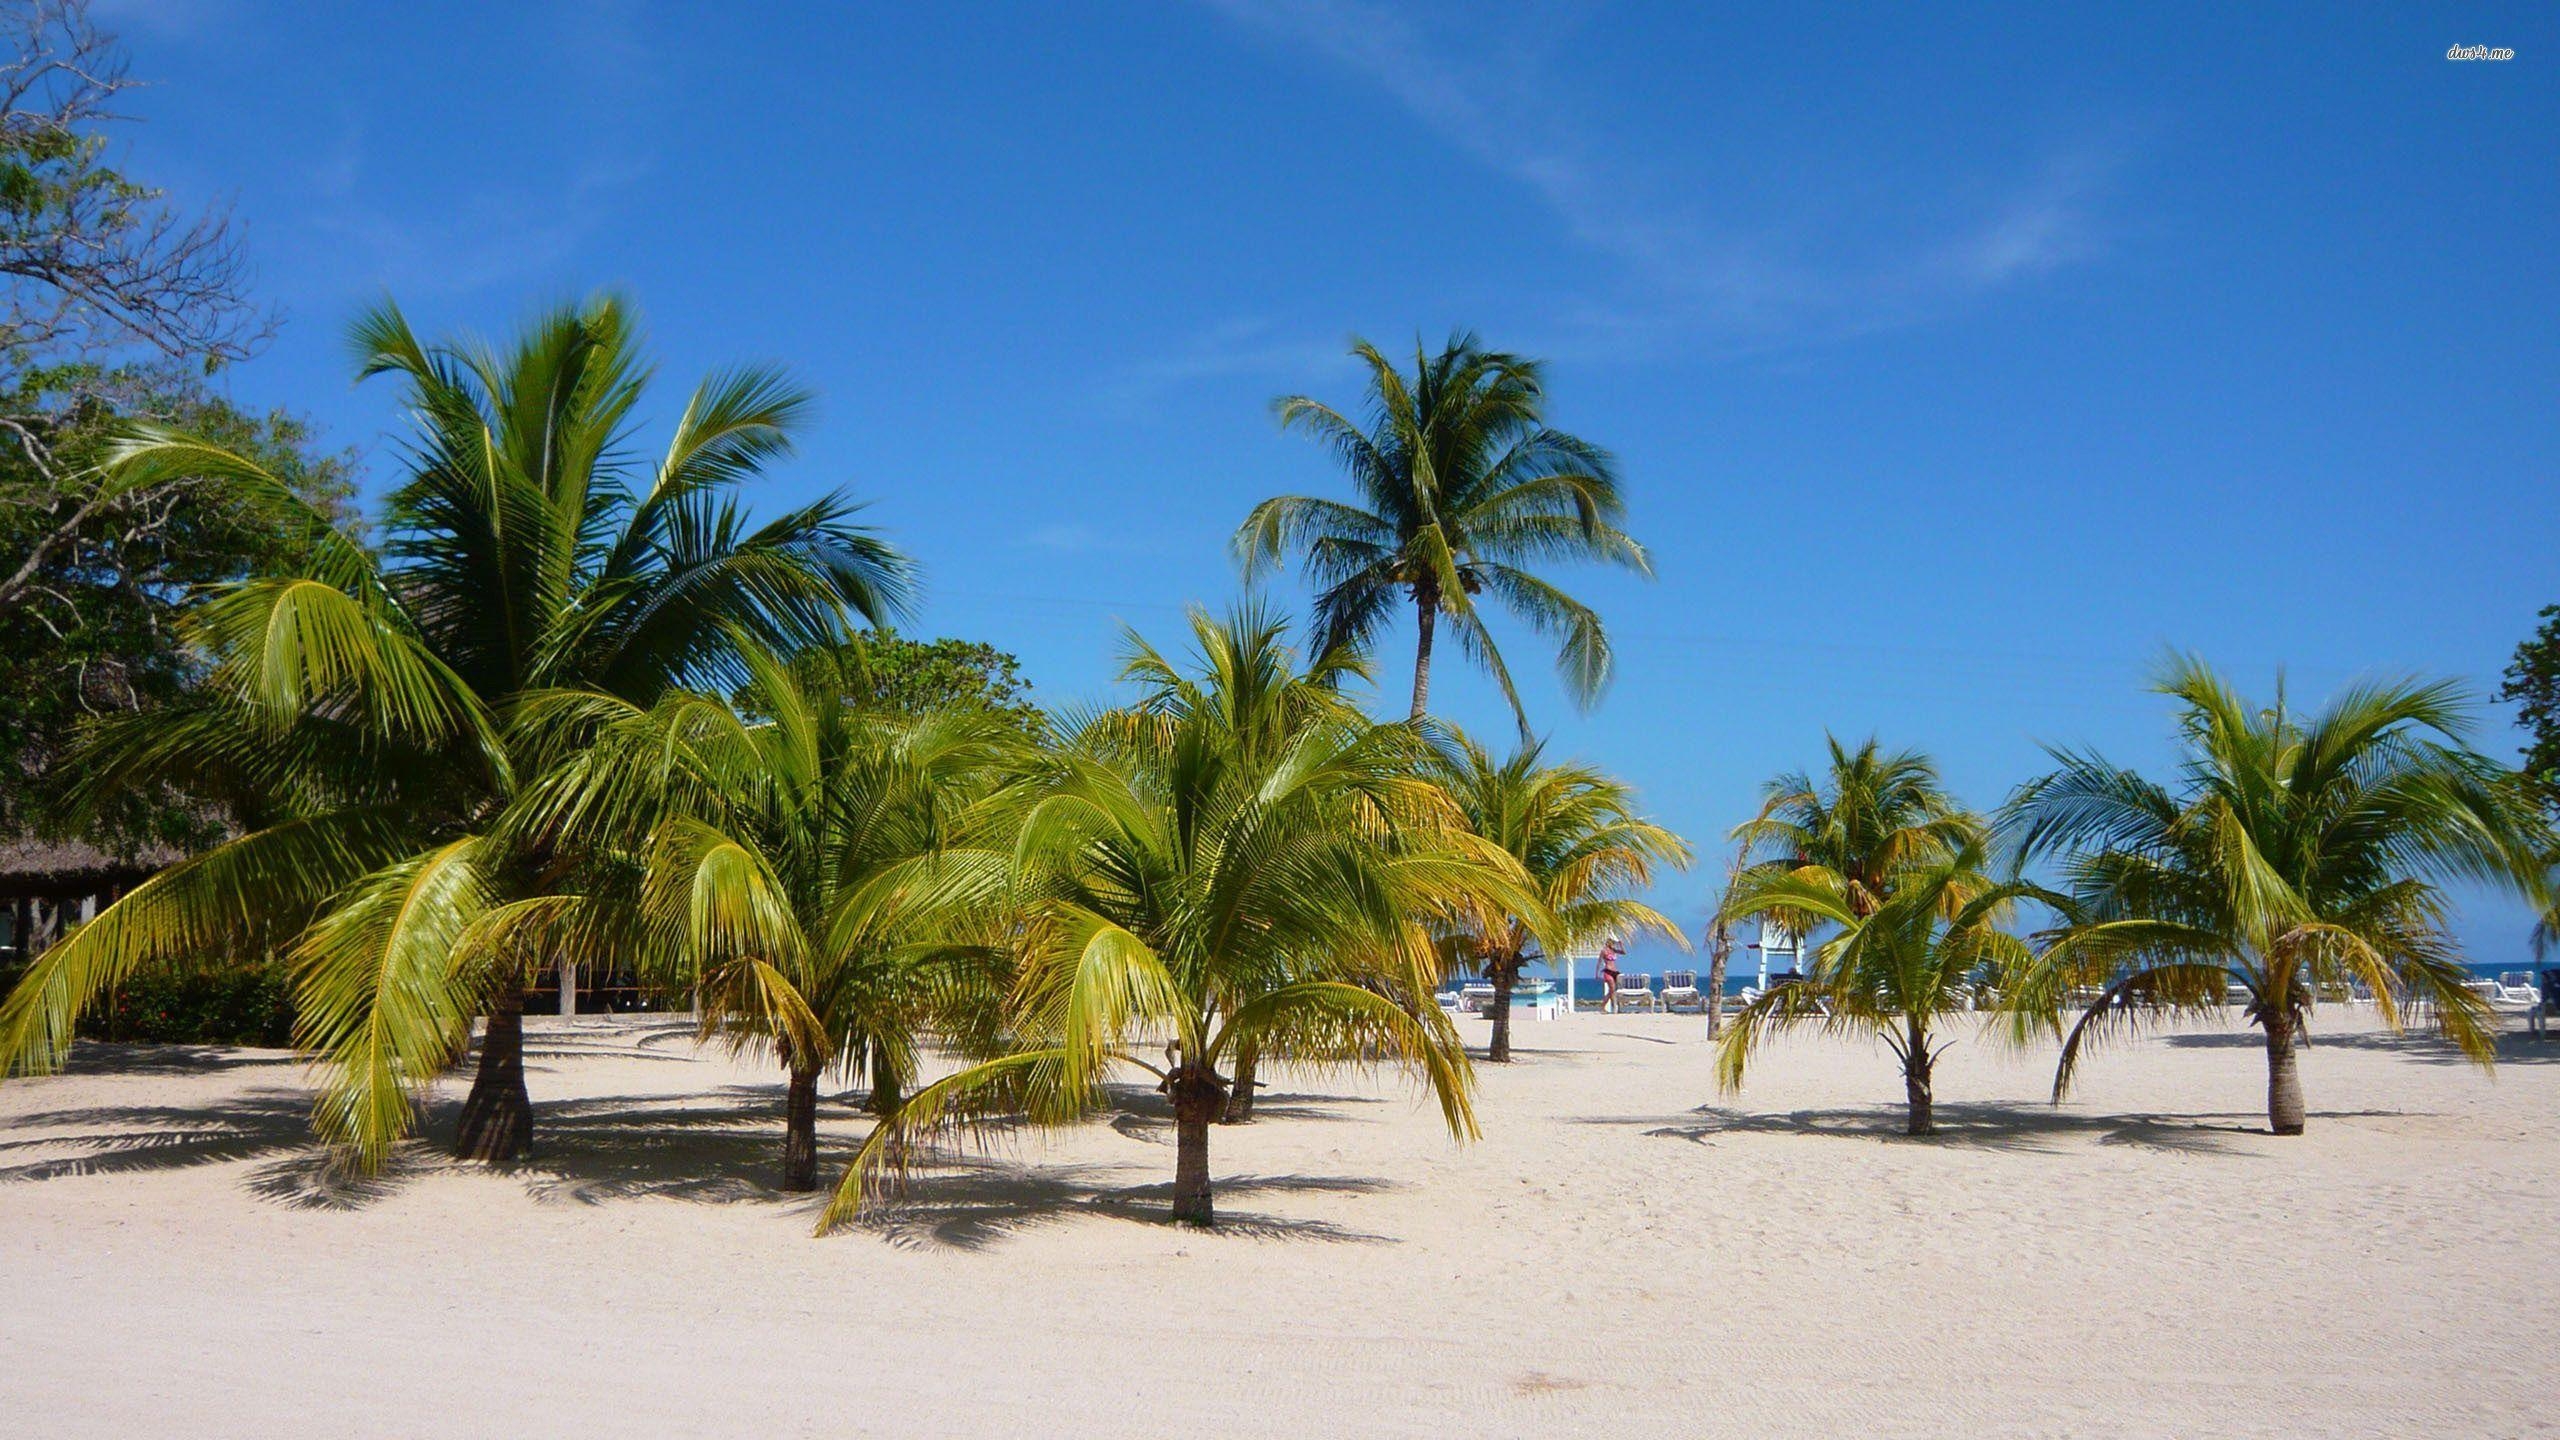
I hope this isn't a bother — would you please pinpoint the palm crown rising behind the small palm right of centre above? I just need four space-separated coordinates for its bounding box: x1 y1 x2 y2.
1720 735 1984 935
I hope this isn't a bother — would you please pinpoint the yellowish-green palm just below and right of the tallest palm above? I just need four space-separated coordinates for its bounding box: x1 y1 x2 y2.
1439 735 1690 1063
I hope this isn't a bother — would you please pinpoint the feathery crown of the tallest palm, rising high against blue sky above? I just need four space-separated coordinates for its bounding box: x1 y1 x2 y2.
1234 336 1651 722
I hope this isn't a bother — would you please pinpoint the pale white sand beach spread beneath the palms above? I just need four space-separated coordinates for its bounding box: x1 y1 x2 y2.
0 1012 2560 1440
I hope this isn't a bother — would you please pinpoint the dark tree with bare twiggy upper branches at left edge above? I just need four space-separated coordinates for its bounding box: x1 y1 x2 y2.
0 0 351 851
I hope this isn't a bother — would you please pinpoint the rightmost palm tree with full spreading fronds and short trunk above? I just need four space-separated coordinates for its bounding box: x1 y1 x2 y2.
2004 659 2552 1135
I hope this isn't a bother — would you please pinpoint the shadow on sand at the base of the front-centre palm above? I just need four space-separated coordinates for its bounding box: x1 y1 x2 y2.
847 1156 1393 1250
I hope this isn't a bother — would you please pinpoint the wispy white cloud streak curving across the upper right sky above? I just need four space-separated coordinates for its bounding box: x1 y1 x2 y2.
1201 0 2107 351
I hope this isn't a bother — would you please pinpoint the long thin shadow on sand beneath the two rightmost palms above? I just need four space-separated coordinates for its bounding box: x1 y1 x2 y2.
1590 1102 2404 1158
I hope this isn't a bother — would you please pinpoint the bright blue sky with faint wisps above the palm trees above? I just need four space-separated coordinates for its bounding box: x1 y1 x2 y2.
90 0 2560 969
